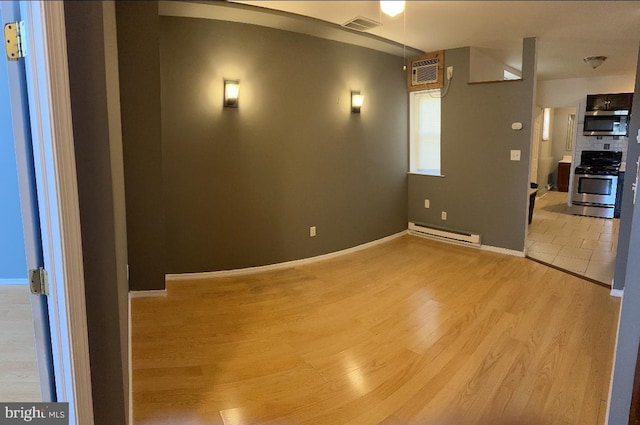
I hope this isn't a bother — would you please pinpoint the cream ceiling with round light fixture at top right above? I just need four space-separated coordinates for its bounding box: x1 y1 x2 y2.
236 0 640 80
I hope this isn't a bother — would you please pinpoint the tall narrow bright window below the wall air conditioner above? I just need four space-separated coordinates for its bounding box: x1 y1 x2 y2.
409 90 441 176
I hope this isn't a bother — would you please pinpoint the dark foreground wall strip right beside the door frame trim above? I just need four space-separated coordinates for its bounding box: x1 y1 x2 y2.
64 2 129 425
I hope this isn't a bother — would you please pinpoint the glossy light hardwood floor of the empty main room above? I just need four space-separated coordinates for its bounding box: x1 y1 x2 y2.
132 236 619 425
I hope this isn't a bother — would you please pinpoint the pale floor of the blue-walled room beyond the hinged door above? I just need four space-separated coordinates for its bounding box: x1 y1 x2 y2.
0 285 41 402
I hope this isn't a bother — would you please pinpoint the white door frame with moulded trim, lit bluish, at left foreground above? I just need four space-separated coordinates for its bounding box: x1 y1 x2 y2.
19 1 94 425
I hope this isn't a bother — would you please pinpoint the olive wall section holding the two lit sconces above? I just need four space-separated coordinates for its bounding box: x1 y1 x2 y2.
160 17 408 273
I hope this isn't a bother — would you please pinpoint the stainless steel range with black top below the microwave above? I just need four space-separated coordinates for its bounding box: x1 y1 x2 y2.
571 151 622 218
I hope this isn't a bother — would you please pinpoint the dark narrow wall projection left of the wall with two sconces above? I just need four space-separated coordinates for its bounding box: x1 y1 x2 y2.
116 1 166 290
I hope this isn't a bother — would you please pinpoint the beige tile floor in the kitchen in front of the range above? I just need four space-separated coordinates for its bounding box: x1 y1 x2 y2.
526 191 620 285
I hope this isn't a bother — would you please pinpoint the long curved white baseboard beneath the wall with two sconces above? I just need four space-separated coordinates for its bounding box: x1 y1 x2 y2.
165 230 407 282
